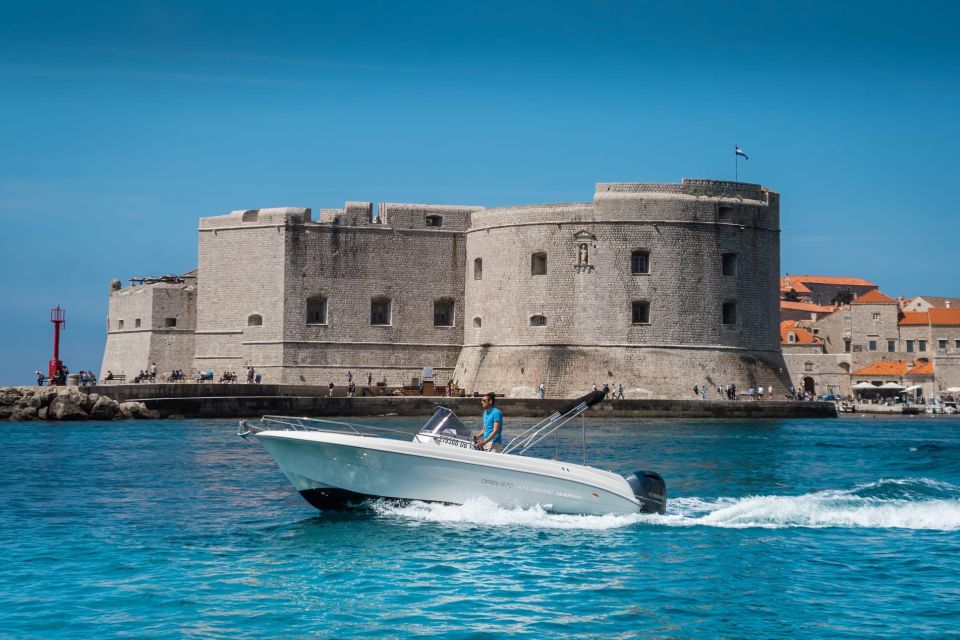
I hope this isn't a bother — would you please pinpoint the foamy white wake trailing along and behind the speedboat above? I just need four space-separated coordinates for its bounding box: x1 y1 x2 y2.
371 478 960 531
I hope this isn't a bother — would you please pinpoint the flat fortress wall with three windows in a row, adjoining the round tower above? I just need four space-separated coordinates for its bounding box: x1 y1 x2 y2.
283 225 465 384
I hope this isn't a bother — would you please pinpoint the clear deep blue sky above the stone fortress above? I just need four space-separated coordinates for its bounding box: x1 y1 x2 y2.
0 0 960 384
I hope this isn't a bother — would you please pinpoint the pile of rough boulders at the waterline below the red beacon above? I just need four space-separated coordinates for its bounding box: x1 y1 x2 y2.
0 387 160 421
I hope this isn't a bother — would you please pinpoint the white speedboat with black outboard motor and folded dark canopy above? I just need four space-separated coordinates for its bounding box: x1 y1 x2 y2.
238 392 667 515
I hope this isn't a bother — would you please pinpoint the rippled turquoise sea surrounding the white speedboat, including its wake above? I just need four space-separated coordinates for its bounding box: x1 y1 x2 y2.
0 416 960 638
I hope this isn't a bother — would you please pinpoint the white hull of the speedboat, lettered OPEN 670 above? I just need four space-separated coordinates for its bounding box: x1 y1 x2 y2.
257 431 641 515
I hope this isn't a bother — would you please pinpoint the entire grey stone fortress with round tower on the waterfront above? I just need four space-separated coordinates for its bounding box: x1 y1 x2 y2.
100 179 790 398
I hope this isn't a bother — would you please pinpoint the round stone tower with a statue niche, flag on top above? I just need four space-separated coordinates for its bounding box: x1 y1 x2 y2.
455 179 789 399
